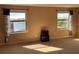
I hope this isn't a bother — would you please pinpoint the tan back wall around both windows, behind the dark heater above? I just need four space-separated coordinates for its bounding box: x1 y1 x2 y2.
0 5 76 43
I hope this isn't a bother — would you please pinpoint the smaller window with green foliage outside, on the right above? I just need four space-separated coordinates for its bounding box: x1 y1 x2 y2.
57 11 71 30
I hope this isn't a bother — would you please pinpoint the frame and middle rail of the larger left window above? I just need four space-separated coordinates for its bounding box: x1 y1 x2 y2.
10 9 28 34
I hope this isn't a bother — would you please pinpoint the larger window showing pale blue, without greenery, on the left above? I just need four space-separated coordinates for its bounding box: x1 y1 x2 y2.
10 10 26 32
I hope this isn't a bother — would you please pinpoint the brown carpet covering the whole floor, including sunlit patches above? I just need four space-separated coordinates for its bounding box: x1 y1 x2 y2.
0 38 79 54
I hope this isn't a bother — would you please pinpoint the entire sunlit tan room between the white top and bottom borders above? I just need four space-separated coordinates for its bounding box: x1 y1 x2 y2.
0 4 79 54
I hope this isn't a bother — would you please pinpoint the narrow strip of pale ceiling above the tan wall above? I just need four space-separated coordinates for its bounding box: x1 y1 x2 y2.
15 4 79 7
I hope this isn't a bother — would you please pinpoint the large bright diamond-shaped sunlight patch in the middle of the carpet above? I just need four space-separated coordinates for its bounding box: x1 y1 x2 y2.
23 44 63 52
